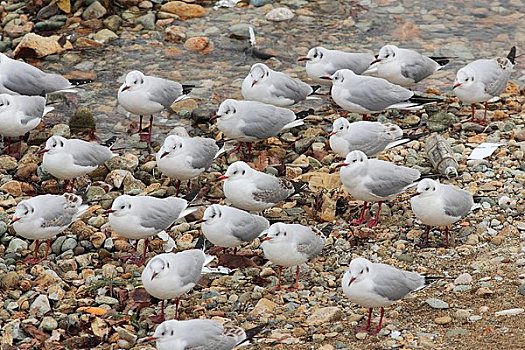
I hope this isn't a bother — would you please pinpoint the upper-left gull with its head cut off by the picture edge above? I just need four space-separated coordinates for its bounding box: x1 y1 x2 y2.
0 53 91 96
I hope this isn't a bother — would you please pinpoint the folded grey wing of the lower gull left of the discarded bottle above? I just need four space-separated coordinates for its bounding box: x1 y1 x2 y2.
366 159 421 197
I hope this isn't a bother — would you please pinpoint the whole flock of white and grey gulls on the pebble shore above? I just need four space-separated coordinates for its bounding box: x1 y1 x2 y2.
0 39 516 350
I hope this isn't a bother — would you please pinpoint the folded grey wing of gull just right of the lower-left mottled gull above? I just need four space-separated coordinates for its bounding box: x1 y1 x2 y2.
137 197 187 232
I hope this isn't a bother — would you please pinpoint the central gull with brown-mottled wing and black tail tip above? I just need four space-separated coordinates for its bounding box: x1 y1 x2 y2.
219 161 305 212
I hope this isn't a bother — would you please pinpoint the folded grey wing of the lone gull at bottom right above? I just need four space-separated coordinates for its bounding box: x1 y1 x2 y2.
372 264 425 301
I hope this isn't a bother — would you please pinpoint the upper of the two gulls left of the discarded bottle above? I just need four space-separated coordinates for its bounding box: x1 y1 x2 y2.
329 117 410 157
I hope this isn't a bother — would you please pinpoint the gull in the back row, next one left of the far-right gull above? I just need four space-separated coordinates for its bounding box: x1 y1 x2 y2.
363 45 450 87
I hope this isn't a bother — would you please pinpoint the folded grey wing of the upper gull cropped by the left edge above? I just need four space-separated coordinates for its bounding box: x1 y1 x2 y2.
2 61 71 96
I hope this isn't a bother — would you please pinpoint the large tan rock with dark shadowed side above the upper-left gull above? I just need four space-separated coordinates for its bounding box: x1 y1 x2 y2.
13 33 73 58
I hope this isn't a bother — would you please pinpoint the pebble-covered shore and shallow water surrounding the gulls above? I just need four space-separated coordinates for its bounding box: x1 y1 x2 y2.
0 0 525 350
